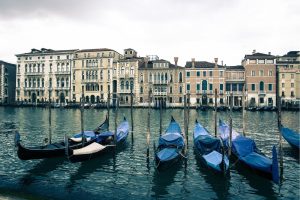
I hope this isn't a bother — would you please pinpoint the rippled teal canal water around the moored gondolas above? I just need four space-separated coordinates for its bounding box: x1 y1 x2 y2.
0 107 300 200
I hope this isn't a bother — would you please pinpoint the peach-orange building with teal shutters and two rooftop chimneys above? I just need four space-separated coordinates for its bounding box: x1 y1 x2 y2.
185 58 226 106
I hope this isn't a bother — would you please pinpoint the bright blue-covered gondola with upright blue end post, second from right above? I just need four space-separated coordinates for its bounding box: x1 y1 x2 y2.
219 120 279 183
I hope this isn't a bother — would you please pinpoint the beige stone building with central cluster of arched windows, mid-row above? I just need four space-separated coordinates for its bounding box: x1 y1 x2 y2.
137 56 185 107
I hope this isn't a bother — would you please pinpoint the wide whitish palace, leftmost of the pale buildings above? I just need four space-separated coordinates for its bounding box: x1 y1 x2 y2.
16 48 76 103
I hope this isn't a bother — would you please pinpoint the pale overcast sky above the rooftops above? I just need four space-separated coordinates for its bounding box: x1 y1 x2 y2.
0 0 300 66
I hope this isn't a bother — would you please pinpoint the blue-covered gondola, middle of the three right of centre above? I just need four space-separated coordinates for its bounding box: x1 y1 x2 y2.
193 120 229 173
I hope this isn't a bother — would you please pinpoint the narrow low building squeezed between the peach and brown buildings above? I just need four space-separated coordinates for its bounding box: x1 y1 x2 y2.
225 65 246 107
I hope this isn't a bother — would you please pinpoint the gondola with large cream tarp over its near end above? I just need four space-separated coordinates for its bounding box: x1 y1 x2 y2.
66 117 129 162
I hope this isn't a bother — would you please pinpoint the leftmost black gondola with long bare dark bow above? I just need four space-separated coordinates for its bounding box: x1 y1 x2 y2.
15 117 109 160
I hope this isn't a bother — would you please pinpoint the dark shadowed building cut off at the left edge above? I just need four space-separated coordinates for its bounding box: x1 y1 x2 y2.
0 60 16 103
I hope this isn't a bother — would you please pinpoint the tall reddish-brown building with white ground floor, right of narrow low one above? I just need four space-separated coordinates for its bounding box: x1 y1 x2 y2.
242 50 276 107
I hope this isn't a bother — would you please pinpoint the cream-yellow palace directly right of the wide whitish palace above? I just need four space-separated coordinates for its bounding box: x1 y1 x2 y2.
72 48 123 104
